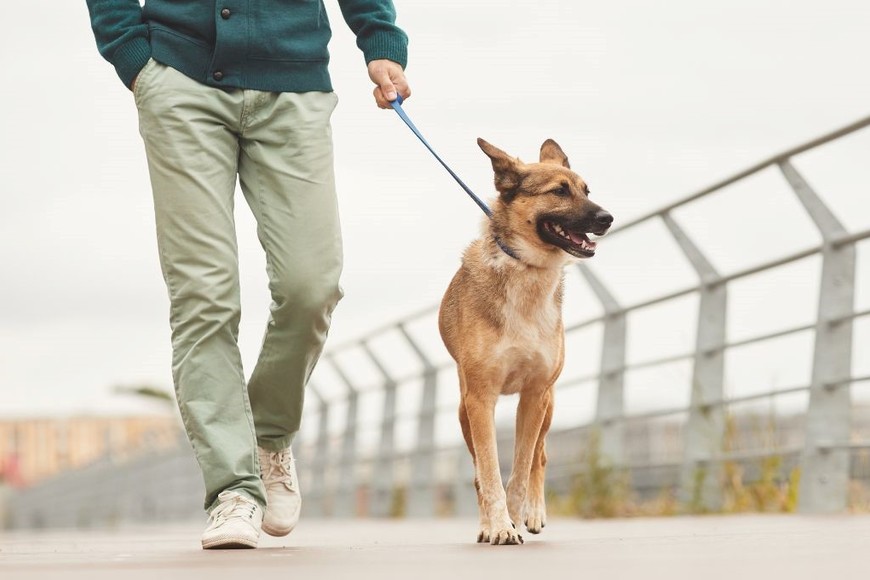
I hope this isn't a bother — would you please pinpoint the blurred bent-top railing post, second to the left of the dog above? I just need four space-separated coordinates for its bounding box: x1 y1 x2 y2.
362 341 396 517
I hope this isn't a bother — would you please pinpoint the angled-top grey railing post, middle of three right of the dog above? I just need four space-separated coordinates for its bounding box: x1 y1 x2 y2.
662 213 728 511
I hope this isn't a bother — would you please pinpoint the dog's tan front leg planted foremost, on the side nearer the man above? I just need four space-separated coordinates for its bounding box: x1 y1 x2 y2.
465 384 523 545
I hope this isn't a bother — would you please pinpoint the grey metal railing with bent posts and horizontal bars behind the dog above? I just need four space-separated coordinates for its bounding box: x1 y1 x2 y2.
296 117 870 516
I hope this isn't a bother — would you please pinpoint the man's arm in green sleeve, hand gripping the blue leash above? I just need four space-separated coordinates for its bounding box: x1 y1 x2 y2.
338 0 411 109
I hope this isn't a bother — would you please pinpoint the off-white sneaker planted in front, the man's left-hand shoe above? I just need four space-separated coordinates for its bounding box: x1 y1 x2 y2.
202 490 263 550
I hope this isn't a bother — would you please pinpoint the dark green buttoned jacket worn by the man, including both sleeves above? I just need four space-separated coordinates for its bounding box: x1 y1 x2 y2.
87 0 408 92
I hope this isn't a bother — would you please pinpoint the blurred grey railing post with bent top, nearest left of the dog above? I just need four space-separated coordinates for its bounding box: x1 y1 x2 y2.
398 324 438 517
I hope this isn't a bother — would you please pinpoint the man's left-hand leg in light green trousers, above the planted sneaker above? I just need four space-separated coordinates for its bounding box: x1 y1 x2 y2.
136 61 266 509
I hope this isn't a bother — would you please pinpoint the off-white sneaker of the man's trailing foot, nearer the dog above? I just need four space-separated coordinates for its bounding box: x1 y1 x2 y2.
257 447 302 536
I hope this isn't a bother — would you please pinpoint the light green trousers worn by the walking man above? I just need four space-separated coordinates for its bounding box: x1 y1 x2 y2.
134 60 341 509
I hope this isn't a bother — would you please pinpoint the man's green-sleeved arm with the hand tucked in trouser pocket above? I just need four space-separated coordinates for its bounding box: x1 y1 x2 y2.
87 0 151 87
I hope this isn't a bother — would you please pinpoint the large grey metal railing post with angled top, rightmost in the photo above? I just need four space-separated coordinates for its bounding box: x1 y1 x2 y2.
779 160 855 513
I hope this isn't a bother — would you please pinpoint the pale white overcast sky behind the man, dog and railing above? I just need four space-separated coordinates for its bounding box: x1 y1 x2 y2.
0 0 870 416
